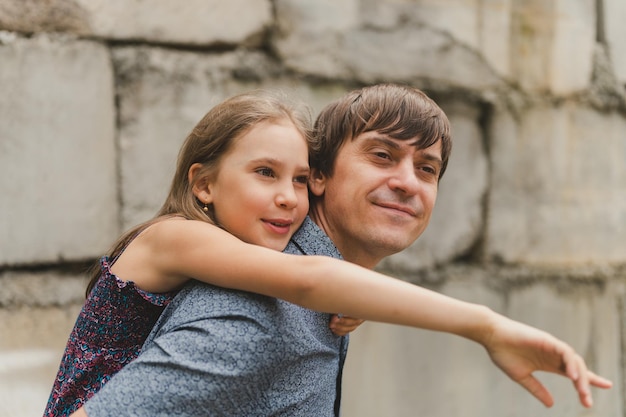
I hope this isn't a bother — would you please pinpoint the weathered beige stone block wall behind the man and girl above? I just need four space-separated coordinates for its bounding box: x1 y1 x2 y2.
0 0 626 417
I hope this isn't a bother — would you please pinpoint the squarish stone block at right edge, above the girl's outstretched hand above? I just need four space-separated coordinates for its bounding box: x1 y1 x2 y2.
486 103 626 265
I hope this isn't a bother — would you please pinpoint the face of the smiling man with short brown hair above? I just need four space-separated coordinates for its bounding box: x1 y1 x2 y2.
310 132 441 268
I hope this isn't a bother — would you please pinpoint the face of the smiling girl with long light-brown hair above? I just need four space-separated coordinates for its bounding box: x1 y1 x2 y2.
201 119 309 250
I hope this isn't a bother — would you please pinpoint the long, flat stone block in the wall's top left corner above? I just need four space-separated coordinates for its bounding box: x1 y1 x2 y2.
0 0 272 45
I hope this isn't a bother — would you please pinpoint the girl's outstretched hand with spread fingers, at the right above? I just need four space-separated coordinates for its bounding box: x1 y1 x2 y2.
484 315 612 407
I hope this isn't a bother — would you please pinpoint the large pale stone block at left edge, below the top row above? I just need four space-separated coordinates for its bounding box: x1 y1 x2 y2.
0 36 118 265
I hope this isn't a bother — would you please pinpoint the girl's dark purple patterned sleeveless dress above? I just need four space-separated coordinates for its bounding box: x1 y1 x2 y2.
44 256 176 417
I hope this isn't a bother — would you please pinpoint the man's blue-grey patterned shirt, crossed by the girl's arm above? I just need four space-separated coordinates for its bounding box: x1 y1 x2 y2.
85 217 347 417
